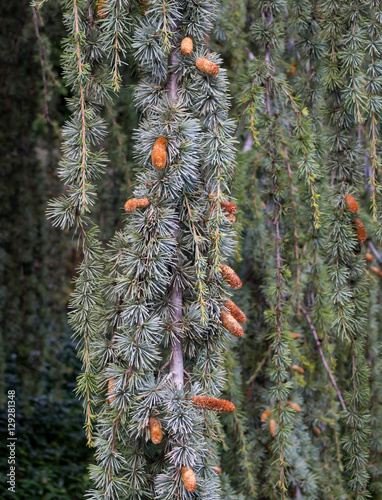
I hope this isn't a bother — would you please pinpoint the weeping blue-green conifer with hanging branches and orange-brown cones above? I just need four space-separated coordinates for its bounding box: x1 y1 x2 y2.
43 0 382 500
